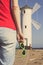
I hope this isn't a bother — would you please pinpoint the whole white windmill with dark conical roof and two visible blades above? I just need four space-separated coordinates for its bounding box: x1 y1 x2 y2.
20 0 40 47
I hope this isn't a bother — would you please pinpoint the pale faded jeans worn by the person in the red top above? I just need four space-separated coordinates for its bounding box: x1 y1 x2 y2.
0 28 16 65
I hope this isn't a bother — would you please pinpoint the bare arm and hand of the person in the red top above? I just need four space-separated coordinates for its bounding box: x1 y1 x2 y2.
12 0 24 42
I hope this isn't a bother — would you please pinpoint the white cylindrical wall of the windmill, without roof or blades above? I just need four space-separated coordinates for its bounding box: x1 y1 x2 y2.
22 8 32 46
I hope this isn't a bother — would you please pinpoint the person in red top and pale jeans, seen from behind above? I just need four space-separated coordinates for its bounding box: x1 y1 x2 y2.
0 0 24 65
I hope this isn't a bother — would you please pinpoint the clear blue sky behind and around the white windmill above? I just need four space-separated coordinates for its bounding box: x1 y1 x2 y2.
19 0 43 47
